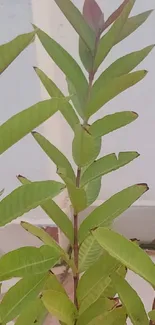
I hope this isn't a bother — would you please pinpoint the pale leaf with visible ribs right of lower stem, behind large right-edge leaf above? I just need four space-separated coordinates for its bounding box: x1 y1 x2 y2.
79 235 103 273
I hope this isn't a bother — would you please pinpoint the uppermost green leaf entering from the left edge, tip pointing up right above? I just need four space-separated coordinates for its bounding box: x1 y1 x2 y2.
0 32 35 74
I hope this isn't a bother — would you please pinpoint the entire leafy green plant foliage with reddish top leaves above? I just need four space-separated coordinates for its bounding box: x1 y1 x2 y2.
0 0 155 325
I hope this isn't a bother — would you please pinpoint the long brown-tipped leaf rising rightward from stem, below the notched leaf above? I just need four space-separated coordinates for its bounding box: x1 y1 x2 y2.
79 184 148 243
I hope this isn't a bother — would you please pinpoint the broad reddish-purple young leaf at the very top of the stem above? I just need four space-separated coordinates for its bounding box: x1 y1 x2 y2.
83 0 104 36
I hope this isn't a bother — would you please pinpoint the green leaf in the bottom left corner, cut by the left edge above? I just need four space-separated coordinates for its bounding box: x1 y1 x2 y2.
0 274 48 323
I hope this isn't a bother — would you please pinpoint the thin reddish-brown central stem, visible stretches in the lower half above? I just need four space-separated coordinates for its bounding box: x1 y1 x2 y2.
74 168 81 309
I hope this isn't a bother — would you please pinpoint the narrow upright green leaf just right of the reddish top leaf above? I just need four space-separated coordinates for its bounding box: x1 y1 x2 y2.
95 0 135 70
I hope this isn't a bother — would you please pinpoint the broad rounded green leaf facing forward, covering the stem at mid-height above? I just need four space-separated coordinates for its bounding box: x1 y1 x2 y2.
72 124 101 167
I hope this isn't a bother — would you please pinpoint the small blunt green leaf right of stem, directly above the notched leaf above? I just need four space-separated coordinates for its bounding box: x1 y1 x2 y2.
89 111 138 137
